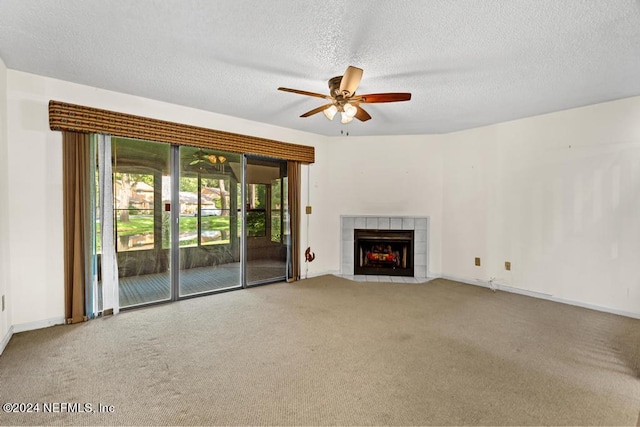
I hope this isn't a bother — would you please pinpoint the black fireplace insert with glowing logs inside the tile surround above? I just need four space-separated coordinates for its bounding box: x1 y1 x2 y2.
353 229 414 277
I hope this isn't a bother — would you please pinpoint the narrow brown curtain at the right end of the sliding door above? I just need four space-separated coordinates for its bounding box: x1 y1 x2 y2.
287 161 301 282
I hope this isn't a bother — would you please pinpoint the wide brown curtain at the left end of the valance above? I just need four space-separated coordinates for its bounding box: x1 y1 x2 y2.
62 132 93 323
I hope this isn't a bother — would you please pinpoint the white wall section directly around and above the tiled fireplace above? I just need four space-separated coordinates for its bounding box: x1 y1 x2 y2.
309 135 442 275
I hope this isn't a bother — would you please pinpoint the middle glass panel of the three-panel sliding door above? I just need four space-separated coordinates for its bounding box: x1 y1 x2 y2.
178 147 242 297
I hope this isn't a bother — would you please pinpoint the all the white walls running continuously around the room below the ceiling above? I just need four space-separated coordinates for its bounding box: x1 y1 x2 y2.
5 66 640 339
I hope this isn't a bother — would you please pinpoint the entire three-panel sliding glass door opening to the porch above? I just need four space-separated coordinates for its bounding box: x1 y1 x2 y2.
96 137 289 308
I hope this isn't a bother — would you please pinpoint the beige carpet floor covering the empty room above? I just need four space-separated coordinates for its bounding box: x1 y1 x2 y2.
0 276 640 426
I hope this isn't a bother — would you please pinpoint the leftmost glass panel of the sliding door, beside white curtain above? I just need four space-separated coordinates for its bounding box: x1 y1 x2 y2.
111 138 171 307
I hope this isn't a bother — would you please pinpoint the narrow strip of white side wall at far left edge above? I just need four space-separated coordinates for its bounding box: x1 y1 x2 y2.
0 58 11 353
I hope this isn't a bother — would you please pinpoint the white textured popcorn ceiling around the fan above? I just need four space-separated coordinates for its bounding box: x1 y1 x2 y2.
0 0 640 135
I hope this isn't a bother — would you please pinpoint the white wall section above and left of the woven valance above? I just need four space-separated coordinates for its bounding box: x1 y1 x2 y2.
6 70 323 331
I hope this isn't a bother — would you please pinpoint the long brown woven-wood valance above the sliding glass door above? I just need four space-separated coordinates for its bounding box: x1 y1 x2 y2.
49 100 315 163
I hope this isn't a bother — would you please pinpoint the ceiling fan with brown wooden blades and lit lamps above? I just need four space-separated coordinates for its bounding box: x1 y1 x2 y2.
278 66 411 123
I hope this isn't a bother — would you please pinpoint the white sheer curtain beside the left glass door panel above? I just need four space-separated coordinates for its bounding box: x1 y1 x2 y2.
98 134 120 314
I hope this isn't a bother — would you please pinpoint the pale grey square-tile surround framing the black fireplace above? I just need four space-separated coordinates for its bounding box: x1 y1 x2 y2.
340 215 429 281
